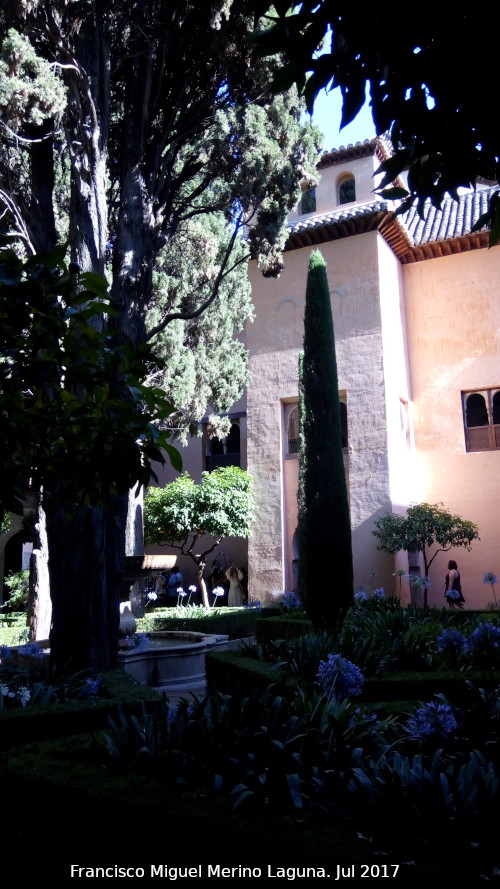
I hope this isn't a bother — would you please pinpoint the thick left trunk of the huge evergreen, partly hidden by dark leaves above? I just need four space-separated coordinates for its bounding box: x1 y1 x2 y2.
43 8 123 672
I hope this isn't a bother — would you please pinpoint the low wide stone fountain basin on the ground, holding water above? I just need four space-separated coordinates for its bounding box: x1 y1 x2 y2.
118 630 229 691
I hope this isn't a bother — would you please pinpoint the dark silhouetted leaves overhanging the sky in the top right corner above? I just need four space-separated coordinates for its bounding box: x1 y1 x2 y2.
252 0 500 244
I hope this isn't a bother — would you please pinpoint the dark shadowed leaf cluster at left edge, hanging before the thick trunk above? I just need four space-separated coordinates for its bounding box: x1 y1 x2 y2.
0 247 180 513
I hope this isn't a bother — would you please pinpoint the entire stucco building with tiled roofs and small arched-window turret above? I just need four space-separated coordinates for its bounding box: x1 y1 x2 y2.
146 139 500 607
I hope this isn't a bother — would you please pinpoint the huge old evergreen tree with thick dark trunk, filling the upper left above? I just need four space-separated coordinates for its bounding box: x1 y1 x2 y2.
0 0 319 669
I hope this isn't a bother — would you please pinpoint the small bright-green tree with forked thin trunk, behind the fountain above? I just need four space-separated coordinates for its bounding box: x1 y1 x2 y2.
144 466 254 607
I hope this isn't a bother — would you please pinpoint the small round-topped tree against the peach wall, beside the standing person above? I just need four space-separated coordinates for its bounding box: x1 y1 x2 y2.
373 503 479 607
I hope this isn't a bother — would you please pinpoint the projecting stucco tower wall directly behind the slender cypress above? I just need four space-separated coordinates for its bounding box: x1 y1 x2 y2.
247 232 409 599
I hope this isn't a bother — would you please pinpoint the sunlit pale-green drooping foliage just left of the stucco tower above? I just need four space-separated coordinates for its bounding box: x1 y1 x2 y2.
147 212 254 443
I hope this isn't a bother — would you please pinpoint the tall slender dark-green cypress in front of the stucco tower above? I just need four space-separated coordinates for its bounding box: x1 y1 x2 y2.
297 250 353 631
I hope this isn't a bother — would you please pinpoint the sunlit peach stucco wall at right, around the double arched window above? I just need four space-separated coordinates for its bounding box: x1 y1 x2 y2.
404 248 500 608
